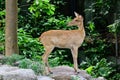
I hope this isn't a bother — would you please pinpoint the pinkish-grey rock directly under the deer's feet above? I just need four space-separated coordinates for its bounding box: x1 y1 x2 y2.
51 66 92 80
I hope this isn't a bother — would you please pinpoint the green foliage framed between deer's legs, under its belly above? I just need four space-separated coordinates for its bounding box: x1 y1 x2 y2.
49 49 73 67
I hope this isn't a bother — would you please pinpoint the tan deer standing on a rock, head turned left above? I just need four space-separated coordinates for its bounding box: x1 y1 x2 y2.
39 12 85 74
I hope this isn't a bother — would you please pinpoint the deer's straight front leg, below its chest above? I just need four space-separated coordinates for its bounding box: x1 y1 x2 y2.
71 47 78 73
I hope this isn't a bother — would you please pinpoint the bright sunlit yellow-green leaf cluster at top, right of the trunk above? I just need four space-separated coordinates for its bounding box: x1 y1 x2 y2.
29 0 55 18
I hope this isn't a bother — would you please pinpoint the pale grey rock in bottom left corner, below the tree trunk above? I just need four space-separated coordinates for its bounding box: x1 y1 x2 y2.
0 65 37 80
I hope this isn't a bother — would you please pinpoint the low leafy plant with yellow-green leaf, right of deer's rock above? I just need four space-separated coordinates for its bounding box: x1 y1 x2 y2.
81 58 115 78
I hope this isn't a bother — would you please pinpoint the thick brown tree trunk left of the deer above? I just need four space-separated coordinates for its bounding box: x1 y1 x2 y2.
5 0 18 56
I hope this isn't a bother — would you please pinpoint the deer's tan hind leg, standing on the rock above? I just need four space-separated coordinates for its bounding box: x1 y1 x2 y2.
42 46 54 74
